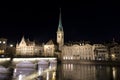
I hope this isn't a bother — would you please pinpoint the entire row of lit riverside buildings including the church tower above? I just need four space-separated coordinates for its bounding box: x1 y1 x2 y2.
0 10 120 60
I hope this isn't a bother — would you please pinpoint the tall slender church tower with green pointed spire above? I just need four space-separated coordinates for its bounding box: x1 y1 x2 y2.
57 9 64 50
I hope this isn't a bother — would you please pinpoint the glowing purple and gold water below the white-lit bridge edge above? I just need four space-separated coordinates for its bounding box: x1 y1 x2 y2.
0 60 57 80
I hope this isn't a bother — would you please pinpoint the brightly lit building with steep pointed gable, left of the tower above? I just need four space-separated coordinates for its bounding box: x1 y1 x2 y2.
16 37 40 56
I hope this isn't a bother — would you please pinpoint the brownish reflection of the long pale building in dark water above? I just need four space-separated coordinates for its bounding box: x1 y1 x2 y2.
62 64 95 80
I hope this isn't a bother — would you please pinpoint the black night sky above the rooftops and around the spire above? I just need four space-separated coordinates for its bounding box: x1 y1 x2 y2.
0 1 120 42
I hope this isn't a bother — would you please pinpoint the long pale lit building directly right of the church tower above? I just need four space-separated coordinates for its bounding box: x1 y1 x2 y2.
62 43 94 60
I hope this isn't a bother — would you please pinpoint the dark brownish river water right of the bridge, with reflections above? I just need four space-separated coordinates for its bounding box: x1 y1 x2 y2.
57 64 120 80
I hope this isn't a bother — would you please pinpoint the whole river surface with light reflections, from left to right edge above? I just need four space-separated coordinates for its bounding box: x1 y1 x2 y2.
0 61 120 80
